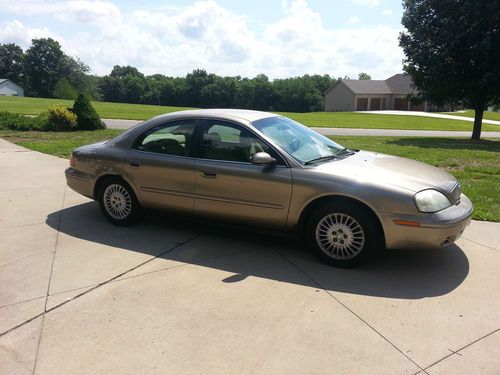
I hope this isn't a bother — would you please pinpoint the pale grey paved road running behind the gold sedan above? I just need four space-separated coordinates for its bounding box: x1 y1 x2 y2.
103 119 500 138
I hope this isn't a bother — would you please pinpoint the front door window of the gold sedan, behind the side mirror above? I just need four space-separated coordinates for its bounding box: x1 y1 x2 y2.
200 120 276 163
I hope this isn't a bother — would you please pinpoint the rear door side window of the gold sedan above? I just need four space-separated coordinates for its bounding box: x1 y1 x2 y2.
133 120 195 156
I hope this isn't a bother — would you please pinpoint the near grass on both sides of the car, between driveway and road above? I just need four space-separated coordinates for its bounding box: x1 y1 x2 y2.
0 129 500 222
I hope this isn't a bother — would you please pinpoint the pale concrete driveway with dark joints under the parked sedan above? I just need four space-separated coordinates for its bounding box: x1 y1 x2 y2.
0 140 500 374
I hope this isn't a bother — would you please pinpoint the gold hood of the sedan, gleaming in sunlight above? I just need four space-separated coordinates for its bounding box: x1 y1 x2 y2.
316 151 457 194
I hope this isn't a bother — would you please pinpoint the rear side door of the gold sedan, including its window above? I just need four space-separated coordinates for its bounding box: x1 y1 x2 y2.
127 120 196 214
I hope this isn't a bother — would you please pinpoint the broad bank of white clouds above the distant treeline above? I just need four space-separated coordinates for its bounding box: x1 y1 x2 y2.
0 0 403 78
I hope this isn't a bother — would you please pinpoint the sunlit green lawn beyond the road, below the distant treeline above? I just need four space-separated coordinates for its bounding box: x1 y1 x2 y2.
0 96 500 132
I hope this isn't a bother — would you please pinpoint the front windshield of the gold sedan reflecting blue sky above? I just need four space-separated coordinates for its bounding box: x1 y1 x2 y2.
252 116 345 164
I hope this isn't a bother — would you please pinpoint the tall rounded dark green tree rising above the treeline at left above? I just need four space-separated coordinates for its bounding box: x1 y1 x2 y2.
25 38 65 98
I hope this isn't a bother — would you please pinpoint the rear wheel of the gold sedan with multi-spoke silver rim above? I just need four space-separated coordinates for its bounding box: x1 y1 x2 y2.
99 177 140 226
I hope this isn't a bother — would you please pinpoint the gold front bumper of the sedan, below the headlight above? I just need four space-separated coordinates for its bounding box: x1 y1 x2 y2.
379 194 474 249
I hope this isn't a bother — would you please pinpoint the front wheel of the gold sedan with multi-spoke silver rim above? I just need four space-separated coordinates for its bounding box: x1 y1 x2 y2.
306 202 377 268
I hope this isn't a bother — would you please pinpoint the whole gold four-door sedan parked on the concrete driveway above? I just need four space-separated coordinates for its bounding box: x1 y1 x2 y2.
66 109 473 267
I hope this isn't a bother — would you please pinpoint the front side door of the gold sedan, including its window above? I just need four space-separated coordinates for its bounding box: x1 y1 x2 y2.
194 119 292 228
